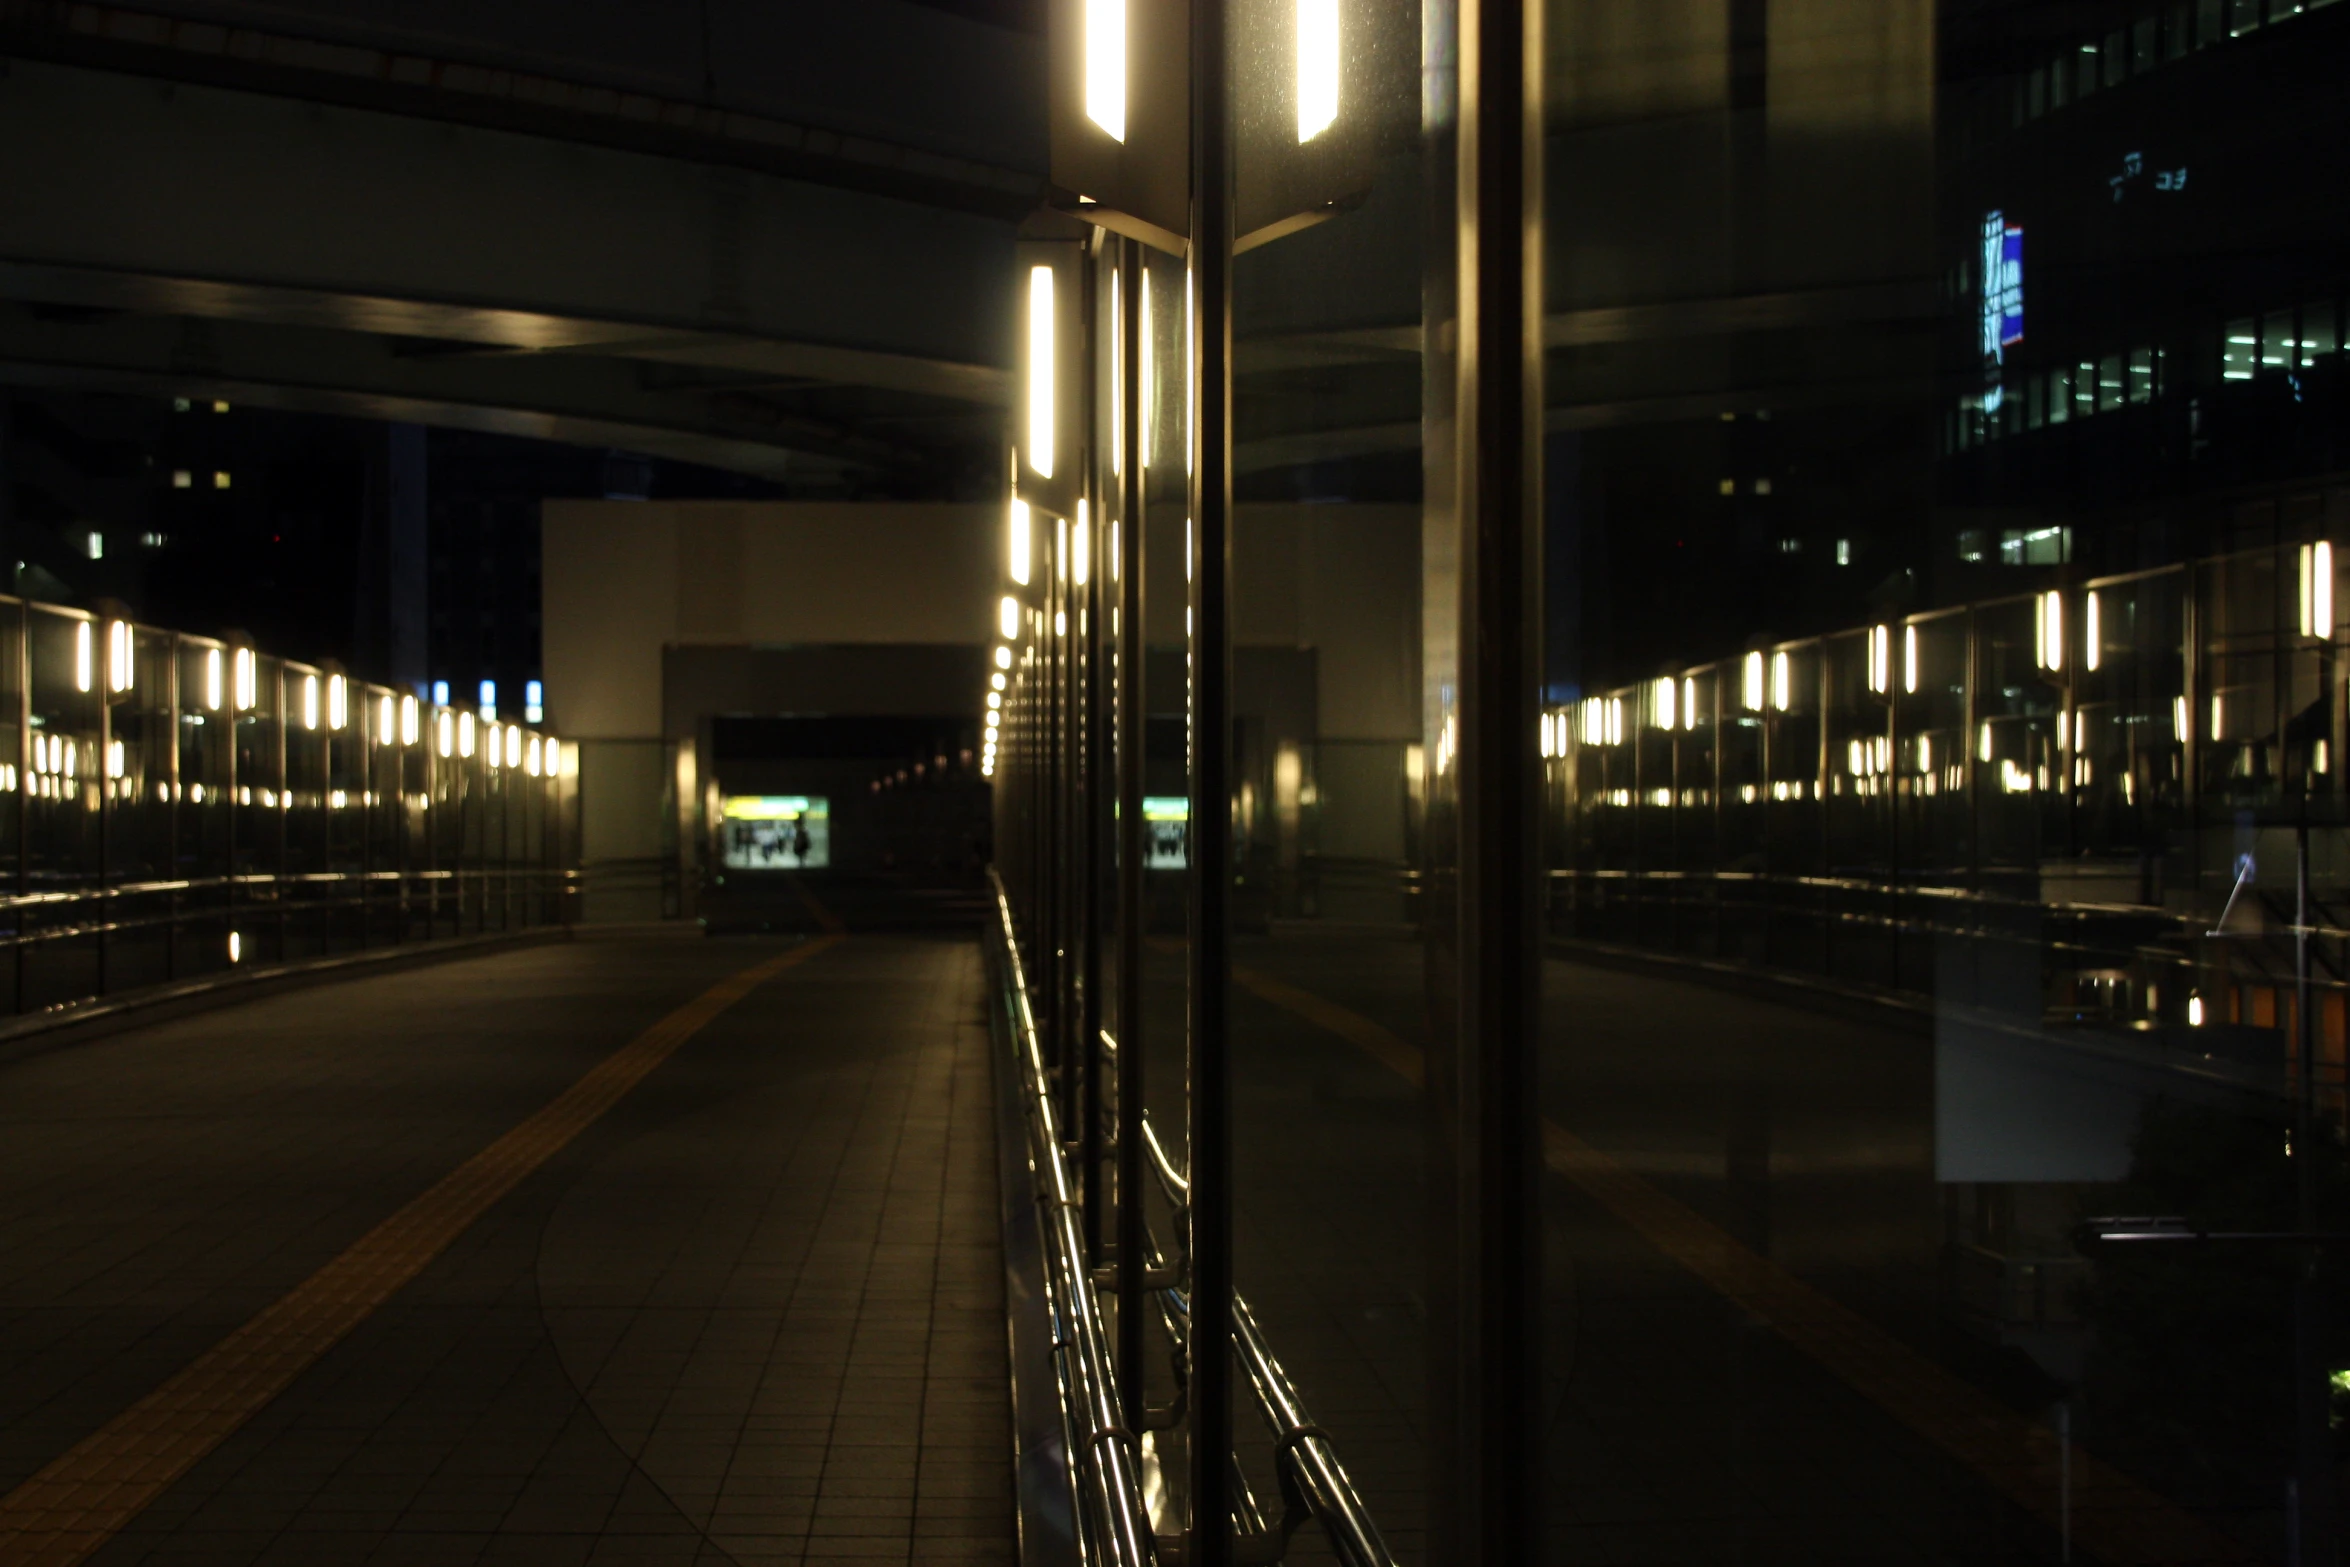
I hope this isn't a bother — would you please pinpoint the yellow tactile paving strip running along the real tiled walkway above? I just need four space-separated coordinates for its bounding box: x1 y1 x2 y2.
0 935 839 1567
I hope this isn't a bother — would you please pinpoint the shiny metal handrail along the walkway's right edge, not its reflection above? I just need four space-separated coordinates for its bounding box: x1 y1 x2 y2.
987 869 1156 1567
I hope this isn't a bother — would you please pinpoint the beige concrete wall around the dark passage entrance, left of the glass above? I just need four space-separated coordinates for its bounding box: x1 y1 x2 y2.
541 500 1001 919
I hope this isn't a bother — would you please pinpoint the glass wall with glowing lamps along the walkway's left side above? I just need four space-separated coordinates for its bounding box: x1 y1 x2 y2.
0 599 578 1013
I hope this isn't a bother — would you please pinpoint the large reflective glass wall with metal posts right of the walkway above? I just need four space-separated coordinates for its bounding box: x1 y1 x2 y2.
978 0 2350 1565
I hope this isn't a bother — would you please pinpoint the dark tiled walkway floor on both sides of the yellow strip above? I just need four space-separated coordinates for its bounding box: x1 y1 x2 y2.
0 937 1013 1567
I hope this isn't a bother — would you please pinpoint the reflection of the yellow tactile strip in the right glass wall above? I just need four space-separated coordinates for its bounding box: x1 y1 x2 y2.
1231 968 2256 1567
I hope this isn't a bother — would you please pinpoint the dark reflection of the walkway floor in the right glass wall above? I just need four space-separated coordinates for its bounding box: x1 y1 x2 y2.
1184 935 2254 1562
